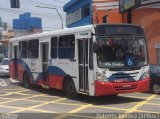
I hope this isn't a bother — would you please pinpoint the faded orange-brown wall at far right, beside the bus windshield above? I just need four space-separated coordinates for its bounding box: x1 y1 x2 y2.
132 8 160 64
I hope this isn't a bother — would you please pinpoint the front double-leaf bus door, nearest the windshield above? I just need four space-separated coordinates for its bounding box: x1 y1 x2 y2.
78 38 89 93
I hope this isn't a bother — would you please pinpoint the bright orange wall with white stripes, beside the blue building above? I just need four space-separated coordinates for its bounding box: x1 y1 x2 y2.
93 0 122 24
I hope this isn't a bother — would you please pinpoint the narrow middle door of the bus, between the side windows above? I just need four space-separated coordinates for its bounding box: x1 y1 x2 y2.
42 42 49 79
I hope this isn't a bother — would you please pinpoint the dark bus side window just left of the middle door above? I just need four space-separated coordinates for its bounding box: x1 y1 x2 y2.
28 39 39 59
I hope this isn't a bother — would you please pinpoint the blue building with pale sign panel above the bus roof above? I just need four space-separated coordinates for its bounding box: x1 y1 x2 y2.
63 0 92 27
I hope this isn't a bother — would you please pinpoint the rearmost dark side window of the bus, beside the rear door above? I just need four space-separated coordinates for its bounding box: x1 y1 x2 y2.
19 41 28 59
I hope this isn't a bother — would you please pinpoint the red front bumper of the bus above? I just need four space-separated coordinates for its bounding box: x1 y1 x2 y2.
95 78 150 96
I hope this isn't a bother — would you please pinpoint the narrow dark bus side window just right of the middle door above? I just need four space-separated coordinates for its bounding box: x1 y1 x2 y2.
51 37 58 59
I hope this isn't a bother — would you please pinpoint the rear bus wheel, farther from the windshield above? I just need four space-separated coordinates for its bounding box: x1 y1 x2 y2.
23 72 31 89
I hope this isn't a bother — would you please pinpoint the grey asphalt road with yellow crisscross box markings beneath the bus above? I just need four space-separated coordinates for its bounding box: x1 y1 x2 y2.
0 78 160 119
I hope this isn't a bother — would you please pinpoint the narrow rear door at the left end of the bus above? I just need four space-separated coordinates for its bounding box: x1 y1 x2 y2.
14 45 19 79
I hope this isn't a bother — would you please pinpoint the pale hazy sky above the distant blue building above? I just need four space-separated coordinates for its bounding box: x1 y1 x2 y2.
0 0 70 31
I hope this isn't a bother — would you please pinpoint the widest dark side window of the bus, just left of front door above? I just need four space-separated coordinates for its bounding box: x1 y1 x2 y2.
58 35 75 59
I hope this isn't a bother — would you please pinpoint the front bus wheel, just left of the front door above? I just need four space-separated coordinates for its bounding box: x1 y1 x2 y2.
64 77 78 99
